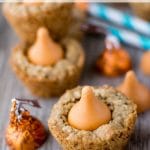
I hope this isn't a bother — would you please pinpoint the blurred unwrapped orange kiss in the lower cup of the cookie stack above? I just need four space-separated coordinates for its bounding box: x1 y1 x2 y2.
28 27 63 66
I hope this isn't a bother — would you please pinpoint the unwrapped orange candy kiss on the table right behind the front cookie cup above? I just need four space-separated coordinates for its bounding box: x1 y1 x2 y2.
117 71 150 113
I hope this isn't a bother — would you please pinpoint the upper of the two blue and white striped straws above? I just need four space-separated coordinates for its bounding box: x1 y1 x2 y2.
88 3 150 36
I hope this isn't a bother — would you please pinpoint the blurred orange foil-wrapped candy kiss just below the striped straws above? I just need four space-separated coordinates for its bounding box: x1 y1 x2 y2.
96 36 132 77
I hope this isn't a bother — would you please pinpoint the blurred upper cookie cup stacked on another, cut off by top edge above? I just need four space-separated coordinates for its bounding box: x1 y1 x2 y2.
3 2 82 43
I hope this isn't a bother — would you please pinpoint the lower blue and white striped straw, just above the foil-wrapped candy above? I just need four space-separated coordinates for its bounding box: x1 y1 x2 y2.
88 18 150 50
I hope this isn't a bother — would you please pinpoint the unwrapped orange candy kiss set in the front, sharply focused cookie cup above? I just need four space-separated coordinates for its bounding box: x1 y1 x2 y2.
68 86 111 130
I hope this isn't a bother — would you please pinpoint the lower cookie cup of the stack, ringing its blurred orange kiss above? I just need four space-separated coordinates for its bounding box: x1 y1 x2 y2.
11 39 85 97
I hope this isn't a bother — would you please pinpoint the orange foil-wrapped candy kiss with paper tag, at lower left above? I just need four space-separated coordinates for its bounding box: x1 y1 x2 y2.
6 98 47 150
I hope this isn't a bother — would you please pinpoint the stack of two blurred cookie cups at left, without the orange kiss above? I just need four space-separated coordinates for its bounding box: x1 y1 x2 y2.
3 2 84 97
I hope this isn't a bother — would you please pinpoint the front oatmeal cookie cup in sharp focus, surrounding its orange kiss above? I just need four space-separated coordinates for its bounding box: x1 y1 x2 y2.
48 86 137 150
